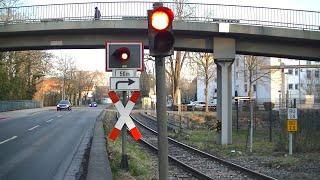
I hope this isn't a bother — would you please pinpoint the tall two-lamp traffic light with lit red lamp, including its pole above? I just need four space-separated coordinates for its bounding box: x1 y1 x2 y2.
148 3 174 180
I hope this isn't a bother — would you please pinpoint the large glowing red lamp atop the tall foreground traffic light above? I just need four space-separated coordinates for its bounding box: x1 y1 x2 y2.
149 7 174 31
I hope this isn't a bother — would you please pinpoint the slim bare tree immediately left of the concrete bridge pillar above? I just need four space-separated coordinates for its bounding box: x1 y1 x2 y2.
190 53 217 112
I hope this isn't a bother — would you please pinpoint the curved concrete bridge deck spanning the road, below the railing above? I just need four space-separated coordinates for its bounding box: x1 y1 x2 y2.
0 20 320 61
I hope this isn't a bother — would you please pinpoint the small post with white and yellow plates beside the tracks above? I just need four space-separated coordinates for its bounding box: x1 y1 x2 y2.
287 108 298 155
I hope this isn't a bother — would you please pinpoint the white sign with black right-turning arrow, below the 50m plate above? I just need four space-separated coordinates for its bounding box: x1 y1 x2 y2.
110 77 140 91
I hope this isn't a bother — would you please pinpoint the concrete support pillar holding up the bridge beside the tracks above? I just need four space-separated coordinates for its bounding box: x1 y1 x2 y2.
213 38 235 144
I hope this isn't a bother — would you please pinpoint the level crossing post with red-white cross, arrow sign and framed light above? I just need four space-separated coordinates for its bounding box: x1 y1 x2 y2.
106 41 143 170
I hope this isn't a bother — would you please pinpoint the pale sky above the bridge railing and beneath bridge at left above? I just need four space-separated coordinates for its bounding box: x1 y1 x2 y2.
22 0 320 71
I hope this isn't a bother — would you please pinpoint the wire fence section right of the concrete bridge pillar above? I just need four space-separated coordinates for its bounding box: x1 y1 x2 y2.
232 98 320 152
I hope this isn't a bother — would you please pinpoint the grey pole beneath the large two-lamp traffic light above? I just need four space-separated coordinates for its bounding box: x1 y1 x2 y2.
155 56 169 180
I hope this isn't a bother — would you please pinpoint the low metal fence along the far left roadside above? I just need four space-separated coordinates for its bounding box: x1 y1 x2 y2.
0 100 40 112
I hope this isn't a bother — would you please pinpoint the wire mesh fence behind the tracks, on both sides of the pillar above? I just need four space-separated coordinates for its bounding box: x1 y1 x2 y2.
143 95 320 152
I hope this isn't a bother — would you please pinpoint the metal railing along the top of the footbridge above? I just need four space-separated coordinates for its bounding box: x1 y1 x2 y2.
0 1 320 31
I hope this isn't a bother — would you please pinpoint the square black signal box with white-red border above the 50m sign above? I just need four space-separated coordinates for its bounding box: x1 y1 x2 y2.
105 41 144 71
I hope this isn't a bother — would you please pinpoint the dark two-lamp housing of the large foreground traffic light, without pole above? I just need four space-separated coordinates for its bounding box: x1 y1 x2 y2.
148 7 175 56
